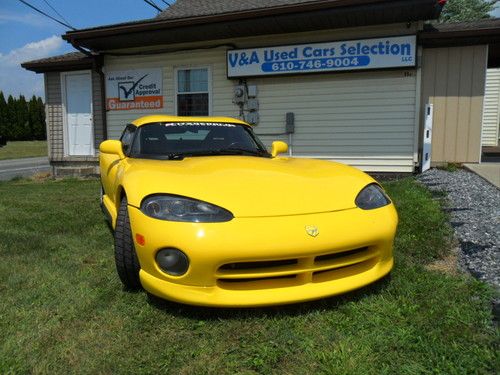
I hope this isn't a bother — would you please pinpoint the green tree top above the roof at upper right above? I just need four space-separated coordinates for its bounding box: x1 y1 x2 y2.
439 0 498 22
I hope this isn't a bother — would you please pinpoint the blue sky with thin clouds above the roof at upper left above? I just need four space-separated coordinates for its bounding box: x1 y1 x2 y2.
0 0 500 100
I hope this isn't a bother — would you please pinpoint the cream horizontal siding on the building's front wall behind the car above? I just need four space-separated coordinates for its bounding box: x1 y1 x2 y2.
105 25 417 172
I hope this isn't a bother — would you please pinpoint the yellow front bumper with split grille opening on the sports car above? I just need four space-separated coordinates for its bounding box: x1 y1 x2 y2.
129 205 397 307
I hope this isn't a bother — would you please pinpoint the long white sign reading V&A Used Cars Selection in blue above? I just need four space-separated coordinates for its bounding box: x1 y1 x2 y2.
227 35 417 78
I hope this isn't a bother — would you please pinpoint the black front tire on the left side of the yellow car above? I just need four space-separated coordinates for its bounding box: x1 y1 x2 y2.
115 198 142 290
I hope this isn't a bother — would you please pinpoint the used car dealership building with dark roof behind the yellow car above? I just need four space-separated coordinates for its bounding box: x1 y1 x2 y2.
23 0 500 175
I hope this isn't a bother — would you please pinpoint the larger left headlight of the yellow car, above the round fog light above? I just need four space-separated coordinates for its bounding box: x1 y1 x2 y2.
141 195 233 223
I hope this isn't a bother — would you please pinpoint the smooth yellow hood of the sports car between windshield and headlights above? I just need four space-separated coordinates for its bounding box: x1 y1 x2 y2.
123 156 374 217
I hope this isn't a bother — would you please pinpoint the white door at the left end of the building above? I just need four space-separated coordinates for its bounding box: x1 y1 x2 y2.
64 72 94 155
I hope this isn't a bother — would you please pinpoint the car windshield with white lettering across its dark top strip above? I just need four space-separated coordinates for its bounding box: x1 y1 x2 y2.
130 122 269 159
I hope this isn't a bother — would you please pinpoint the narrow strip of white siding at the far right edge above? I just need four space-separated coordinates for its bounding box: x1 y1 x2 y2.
481 68 500 146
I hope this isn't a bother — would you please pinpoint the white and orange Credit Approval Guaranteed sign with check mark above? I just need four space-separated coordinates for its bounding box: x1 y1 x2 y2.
106 68 163 111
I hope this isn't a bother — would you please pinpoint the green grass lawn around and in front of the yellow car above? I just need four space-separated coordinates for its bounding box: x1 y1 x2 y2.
0 178 499 374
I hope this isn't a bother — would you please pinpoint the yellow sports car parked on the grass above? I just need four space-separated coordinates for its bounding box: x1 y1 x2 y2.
99 115 398 307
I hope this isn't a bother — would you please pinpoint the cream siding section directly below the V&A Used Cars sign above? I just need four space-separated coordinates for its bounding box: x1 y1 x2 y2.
249 70 416 172
